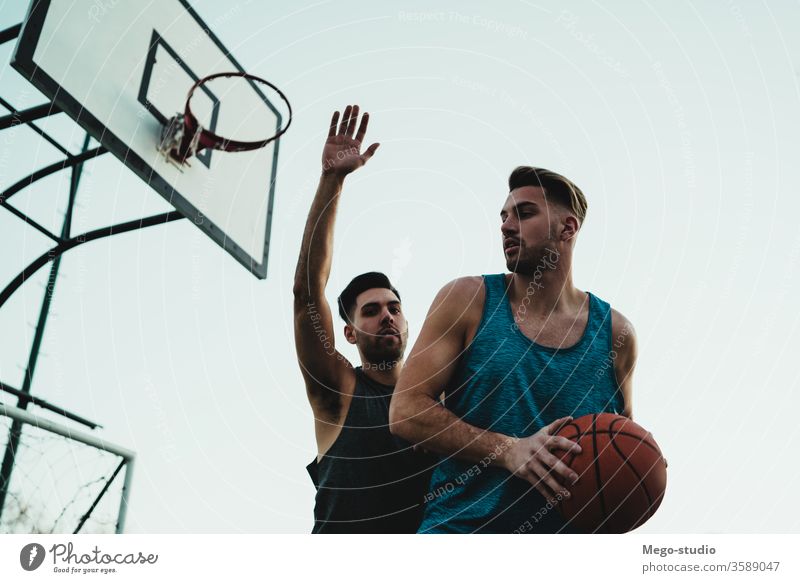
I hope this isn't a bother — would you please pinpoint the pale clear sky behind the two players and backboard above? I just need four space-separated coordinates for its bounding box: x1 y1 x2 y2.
0 0 800 533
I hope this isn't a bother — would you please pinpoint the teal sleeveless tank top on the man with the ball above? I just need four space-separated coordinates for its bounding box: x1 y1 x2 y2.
418 273 624 533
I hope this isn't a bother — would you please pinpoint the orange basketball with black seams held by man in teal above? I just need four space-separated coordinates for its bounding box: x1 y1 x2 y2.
557 413 667 533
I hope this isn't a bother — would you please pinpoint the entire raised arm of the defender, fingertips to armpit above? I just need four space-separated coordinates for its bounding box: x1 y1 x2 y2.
293 105 378 412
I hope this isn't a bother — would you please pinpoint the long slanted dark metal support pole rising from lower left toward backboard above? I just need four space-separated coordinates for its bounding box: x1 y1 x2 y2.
0 134 89 518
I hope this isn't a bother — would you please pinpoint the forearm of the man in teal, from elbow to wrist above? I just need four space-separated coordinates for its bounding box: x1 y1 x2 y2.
389 394 518 466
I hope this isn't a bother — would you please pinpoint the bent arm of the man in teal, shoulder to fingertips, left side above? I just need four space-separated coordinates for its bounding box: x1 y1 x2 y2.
389 277 580 498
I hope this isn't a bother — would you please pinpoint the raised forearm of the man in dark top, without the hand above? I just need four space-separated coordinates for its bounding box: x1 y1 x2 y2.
294 173 344 299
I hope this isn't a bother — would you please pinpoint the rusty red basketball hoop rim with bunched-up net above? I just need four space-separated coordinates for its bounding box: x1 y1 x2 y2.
158 72 292 168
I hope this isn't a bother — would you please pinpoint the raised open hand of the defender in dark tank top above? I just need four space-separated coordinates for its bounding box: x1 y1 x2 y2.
322 105 380 176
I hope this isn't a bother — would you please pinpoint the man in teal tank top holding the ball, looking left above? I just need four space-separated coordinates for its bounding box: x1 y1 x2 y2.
389 166 636 533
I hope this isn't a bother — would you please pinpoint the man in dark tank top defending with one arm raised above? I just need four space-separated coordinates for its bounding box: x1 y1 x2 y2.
294 106 433 533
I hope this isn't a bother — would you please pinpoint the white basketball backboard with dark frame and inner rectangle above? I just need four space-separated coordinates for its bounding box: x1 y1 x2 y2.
12 0 282 278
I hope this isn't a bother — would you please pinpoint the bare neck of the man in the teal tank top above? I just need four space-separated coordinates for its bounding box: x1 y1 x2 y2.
508 253 586 317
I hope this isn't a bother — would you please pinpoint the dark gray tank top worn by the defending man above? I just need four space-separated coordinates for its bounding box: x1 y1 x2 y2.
307 367 435 533
